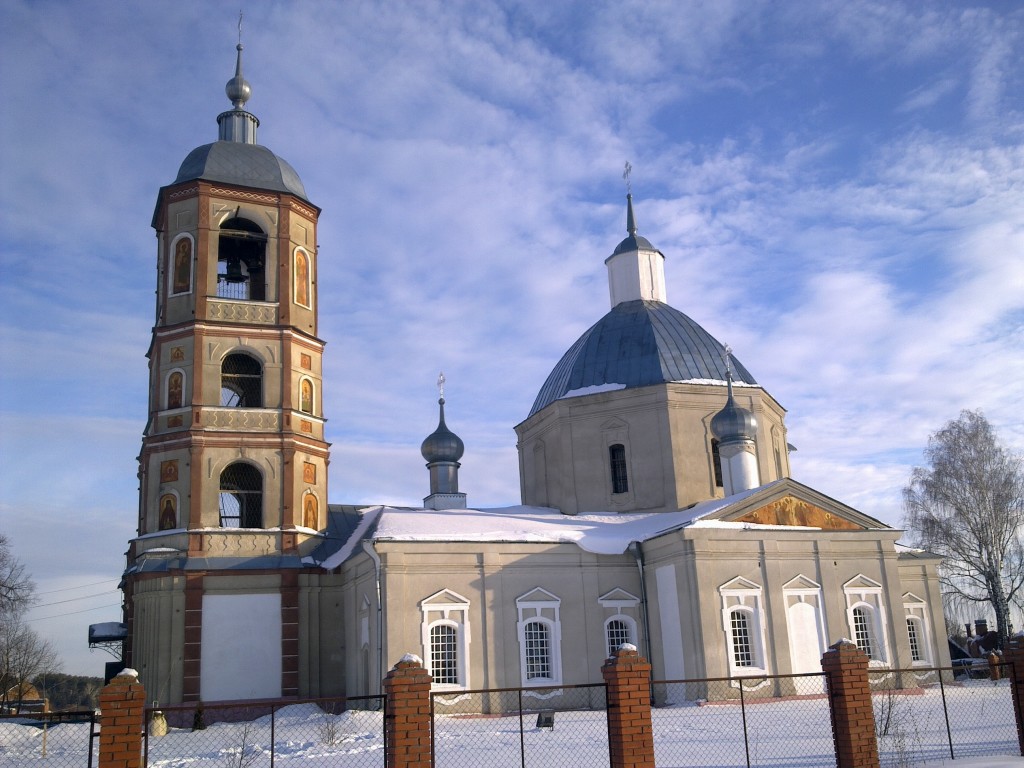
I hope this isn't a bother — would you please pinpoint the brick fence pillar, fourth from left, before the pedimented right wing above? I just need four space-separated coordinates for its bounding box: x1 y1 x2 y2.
821 640 879 768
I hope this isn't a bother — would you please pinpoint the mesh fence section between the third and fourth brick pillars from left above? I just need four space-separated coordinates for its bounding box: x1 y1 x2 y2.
651 674 836 768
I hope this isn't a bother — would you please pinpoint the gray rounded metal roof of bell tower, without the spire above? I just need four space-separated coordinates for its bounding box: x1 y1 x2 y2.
174 141 308 201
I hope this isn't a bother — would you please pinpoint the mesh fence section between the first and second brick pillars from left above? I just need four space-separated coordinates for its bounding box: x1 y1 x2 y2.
144 696 384 768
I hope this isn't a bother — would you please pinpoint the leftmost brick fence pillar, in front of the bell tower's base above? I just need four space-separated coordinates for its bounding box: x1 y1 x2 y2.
98 670 145 768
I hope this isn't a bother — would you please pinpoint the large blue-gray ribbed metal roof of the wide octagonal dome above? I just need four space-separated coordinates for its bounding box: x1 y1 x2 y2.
529 300 757 416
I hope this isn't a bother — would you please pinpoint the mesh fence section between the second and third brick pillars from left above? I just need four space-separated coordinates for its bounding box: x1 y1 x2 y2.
431 683 608 768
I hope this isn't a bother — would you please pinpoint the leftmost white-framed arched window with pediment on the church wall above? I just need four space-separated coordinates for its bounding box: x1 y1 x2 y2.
420 590 470 689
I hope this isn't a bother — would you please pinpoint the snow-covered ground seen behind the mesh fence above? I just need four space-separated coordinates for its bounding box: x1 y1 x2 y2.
0 682 1024 768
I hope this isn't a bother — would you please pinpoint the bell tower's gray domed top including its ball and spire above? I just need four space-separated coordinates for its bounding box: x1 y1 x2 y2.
174 43 308 200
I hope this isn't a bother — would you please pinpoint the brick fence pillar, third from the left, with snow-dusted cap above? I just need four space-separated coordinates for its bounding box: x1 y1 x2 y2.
601 644 654 768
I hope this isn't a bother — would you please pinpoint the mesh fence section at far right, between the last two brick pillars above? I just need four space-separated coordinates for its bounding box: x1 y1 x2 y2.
868 665 1020 766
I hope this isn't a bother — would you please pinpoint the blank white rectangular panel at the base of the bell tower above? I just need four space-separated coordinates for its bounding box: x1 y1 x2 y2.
200 595 281 701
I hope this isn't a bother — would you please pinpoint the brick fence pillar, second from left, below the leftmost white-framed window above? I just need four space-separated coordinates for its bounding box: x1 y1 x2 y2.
384 653 431 768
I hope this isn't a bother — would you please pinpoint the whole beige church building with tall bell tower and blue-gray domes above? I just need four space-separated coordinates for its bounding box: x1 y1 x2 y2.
122 45 949 708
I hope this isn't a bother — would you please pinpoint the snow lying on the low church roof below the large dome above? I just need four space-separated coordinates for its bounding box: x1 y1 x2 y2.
362 488 782 567
